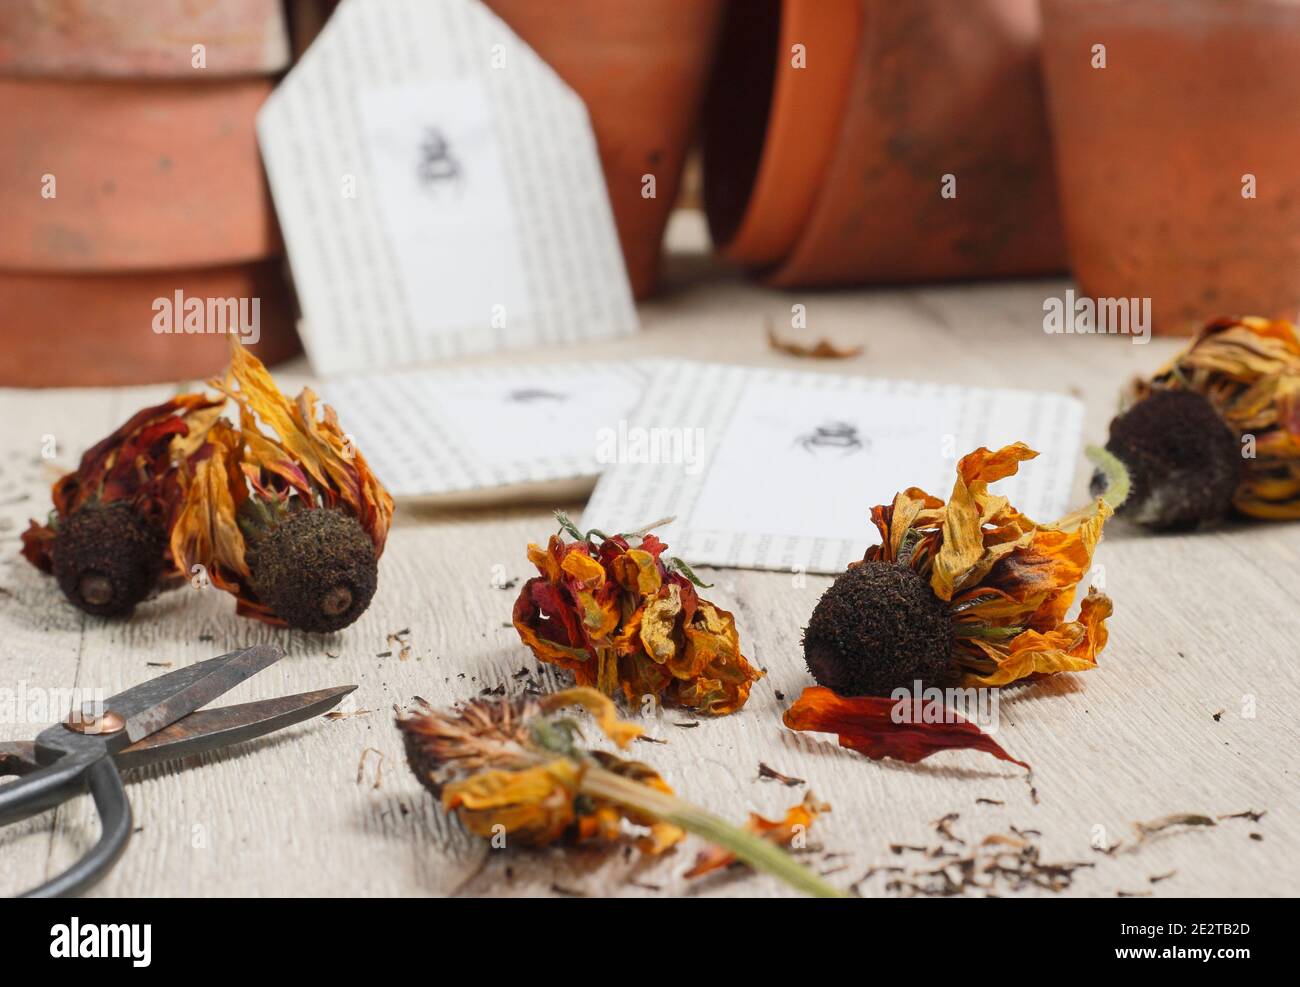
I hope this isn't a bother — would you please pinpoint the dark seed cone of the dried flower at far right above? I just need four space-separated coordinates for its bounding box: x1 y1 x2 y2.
1092 390 1244 529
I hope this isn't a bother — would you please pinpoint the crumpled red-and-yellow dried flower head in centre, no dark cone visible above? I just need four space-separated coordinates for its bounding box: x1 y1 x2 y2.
515 515 763 714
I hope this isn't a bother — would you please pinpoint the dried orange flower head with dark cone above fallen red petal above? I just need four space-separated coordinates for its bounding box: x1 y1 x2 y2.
803 442 1112 696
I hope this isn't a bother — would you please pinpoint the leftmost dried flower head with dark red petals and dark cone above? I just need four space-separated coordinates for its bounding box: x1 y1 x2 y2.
22 394 224 616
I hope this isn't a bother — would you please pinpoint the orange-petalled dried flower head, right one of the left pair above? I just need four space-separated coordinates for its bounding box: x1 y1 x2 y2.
172 345 393 631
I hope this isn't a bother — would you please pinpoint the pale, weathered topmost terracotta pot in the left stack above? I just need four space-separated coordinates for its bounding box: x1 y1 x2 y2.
0 0 289 79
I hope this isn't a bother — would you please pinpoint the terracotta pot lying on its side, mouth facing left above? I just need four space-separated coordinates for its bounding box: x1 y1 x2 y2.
705 0 1065 287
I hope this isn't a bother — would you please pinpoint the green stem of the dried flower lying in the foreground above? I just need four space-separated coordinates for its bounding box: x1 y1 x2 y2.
580 765 848 897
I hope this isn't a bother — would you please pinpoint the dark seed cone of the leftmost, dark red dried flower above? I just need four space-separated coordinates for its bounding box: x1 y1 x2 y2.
51 501 165 616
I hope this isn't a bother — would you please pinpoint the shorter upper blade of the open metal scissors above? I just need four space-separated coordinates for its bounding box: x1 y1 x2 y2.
104 644 285 743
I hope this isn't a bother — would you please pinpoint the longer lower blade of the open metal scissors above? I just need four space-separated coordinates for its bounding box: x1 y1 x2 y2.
113 685 356 771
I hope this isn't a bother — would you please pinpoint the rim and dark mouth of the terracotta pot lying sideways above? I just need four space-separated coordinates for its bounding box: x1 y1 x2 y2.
705 0 862 268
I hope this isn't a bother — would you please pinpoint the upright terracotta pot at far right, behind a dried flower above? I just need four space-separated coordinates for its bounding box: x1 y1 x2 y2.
1044 0 1300 334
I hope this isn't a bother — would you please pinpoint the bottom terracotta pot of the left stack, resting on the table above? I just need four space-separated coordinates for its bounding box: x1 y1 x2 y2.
0 260 299 388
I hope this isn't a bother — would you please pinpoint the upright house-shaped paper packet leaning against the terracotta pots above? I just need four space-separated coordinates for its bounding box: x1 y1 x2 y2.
257 0 637 375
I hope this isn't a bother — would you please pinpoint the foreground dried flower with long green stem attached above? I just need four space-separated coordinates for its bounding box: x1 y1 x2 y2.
398 685 840 897
